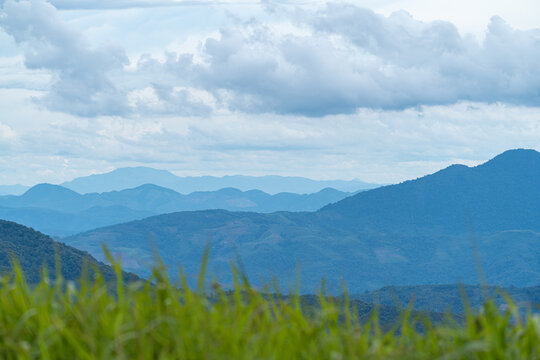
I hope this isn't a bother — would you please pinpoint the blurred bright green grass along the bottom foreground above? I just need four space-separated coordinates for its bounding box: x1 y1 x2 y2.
0 256 540 359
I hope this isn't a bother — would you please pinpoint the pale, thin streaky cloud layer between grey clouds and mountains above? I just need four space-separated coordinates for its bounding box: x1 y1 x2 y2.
0 89 540 184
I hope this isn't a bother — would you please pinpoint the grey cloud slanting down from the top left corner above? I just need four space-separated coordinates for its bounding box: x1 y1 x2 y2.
0 0 128 116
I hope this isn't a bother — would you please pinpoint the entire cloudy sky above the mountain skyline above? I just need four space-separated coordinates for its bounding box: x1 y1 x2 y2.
0 0 540 185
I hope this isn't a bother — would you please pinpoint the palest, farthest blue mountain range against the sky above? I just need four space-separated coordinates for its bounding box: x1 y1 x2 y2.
61 167 378 194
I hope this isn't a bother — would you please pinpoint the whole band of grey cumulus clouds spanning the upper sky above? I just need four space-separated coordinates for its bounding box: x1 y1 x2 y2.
0 0 540 117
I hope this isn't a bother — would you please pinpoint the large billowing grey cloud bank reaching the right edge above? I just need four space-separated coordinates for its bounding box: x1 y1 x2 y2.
134 4 540 117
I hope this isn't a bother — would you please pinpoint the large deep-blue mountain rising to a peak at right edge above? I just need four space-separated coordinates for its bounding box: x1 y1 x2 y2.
65 150 540 292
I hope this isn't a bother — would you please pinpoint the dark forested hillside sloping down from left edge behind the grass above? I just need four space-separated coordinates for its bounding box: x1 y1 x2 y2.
0 220 136 283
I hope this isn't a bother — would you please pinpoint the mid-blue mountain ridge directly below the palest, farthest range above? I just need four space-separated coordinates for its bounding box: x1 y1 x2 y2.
0 184 350 237
